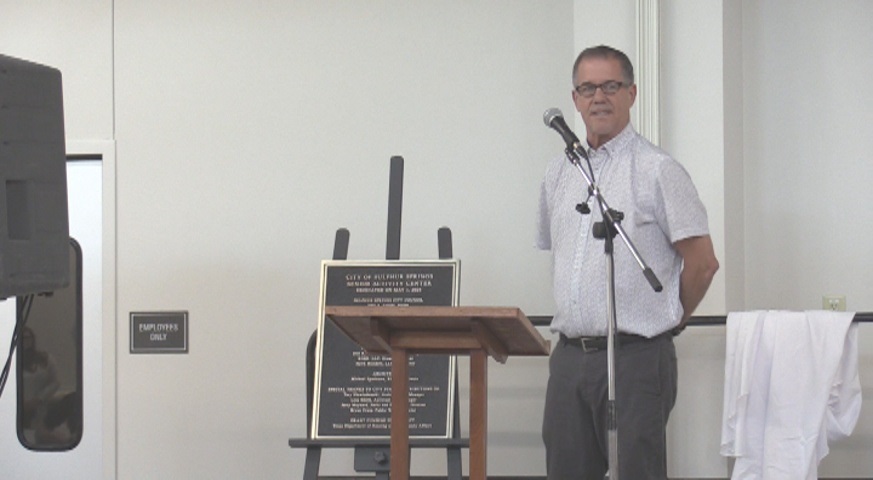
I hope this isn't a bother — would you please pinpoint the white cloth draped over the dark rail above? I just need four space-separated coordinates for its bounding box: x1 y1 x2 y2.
721 311 861 480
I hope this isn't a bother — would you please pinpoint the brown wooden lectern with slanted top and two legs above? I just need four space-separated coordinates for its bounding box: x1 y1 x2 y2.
325 306 550 480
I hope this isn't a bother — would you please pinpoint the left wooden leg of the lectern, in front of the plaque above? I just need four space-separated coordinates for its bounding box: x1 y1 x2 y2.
391 348 409 480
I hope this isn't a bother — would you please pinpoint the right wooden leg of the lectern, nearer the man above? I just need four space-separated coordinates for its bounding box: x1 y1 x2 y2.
470 350 488 480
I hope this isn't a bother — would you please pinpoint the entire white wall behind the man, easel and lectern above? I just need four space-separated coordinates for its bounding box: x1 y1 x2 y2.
0 0 873 478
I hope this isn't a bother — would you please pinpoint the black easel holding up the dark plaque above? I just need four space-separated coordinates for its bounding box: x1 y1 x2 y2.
288 156 470 480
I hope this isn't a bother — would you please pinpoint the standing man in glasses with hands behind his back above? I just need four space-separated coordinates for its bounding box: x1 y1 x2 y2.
537 46 718 480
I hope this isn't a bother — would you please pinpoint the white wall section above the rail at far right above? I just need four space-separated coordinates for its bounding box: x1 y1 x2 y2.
744 0 873 310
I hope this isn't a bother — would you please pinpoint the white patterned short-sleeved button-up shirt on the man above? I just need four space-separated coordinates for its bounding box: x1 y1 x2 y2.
536 124 709 337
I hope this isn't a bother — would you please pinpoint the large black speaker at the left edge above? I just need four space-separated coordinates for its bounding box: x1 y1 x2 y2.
0 55 70 299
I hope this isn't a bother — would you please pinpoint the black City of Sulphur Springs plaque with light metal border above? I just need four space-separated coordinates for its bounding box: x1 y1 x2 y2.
311 260 460 439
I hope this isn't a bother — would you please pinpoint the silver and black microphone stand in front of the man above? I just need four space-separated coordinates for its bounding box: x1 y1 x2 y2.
564 145 663 480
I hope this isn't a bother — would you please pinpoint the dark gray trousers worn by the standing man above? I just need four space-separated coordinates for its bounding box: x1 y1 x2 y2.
543 335 677 480
